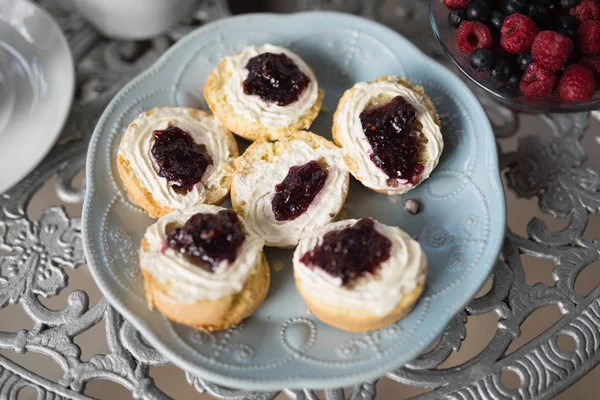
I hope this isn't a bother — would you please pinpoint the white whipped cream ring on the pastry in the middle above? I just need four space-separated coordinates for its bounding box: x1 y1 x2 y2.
232 138 350 247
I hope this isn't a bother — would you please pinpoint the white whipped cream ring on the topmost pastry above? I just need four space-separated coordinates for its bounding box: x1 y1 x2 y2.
214 44 319 128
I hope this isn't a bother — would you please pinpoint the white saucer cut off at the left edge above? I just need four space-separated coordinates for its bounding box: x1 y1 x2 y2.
0 0 75 193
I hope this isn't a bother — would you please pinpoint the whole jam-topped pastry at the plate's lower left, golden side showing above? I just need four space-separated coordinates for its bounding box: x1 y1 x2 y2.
140 204 270 331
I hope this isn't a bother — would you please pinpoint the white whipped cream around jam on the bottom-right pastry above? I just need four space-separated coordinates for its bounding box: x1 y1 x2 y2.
293 219 427 315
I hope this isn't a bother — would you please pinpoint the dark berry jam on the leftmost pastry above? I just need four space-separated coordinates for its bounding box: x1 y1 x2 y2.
151 126 212 194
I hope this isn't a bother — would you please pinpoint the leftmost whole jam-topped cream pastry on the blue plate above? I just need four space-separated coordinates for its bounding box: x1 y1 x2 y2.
117 107 238 218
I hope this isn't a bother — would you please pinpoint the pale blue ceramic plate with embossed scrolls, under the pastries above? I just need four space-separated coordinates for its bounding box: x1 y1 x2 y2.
83 12 506 390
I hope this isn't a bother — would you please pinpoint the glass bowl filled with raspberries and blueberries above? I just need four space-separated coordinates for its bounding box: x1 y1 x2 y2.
430 0 600 112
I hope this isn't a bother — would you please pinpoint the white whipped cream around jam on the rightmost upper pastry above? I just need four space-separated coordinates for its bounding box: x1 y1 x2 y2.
335 77 444 194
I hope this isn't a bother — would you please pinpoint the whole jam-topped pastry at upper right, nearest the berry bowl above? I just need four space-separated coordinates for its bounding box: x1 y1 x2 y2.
333 76 444 194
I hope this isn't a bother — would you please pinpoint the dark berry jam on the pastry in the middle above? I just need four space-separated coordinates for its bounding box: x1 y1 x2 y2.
271 161 329 221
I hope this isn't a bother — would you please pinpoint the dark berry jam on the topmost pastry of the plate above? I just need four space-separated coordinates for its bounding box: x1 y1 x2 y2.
244 53 310 106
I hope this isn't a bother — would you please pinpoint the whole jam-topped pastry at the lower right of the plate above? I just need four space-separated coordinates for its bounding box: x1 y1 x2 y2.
293 218 427 332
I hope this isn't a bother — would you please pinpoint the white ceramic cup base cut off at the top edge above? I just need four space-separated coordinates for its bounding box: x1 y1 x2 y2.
72 0 198 40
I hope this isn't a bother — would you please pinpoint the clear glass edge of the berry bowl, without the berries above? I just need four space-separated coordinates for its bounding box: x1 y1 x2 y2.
429 0 600 113
